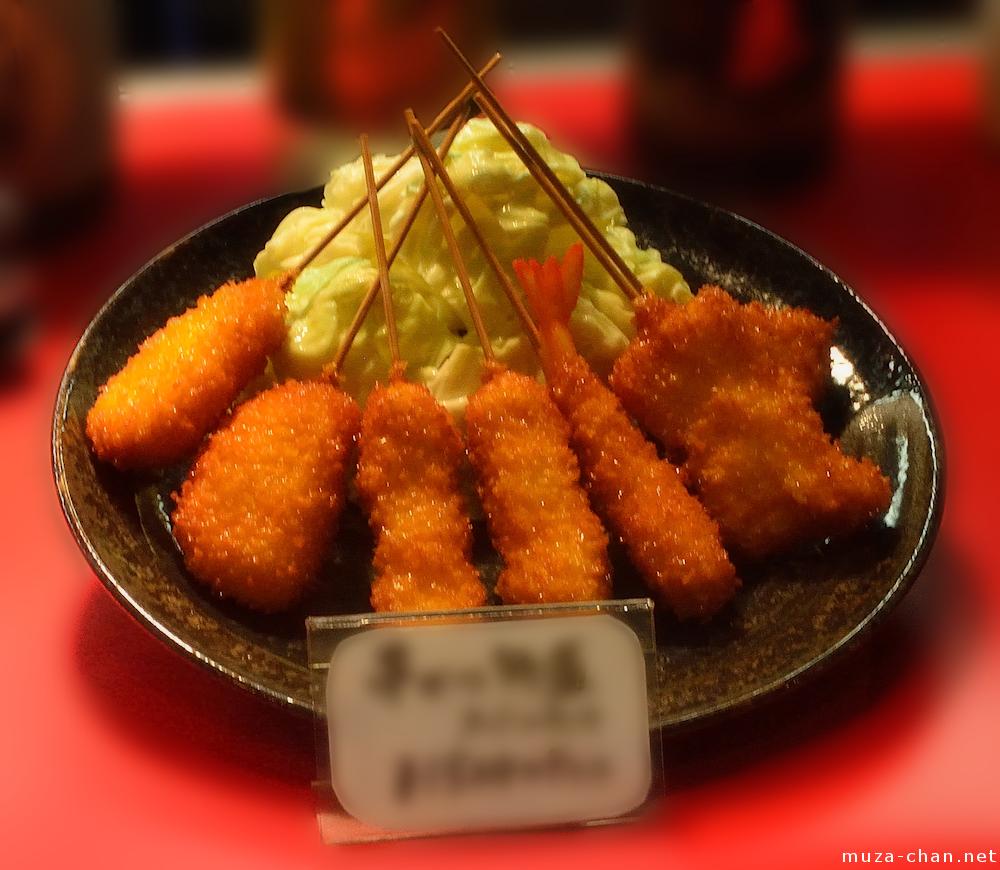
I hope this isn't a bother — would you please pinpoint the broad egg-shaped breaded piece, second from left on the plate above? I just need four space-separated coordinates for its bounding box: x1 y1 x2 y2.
173 381 361 613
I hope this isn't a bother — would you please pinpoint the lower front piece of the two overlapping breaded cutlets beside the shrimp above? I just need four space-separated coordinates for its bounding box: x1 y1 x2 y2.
686 386 891 558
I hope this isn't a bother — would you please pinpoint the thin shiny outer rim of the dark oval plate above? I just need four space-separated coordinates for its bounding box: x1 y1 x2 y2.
50 175 947 732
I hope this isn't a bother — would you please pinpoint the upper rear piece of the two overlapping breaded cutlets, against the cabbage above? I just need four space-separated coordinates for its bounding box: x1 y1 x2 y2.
609 287 835 460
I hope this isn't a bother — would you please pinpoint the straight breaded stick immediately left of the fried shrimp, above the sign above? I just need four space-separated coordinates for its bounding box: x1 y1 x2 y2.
465 371 611 604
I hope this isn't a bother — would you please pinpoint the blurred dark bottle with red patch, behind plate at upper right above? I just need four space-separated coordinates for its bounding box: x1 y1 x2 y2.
630 0 849 193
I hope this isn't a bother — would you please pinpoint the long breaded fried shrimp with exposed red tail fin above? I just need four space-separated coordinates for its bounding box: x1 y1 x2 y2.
514 244 739 619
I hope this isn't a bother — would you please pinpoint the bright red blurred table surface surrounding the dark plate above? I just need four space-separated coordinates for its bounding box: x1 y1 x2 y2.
0 56 1000 868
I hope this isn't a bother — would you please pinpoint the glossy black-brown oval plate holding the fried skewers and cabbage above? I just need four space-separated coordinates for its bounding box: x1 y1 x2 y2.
52 176 943 728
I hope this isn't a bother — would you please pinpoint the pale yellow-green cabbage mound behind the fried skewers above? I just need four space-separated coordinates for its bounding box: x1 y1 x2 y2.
254 118 691 417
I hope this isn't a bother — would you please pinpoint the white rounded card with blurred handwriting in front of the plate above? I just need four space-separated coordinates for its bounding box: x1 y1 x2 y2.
327 615 651 832
